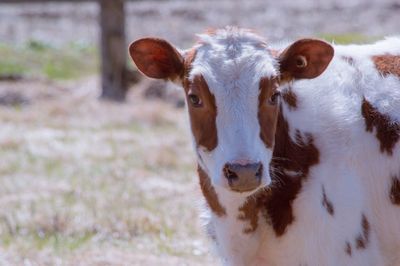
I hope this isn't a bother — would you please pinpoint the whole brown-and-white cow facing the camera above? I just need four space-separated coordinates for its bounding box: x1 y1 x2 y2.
129 27 400 266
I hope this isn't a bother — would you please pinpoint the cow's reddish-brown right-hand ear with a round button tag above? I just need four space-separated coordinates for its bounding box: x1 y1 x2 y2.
278 39 334 80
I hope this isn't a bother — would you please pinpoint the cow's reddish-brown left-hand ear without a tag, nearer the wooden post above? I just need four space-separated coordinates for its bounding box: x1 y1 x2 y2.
129 38 183 80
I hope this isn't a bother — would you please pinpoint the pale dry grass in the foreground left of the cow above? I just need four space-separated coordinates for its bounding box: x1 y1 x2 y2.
0 78 215 265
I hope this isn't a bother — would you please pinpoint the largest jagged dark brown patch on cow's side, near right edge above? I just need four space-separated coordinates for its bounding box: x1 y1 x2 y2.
361 99 400 155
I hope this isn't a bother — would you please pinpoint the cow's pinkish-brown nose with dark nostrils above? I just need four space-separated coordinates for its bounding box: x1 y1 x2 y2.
223 162 263 192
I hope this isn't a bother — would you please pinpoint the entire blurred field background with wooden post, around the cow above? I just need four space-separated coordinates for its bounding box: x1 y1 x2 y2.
0 0 400 265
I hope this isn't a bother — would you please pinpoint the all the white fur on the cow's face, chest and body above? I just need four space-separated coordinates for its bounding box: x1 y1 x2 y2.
191 30 400 266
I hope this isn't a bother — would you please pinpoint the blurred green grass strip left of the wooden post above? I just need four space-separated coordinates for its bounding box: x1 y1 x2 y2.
0 40 98 80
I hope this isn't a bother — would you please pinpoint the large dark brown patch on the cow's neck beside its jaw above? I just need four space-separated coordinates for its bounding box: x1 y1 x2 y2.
266 112 319 236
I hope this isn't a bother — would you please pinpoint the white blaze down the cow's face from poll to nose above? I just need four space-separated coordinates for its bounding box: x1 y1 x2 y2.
189 28 278 187
